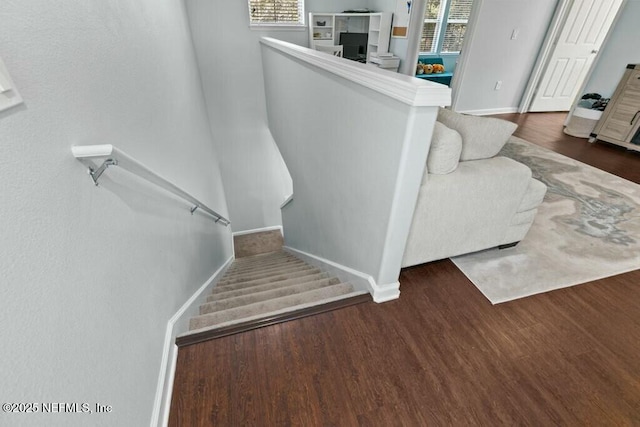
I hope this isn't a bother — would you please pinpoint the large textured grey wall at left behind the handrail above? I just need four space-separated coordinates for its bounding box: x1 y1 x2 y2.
0 0 231 426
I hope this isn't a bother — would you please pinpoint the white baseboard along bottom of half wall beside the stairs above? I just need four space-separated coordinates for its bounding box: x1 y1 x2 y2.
284 246 400 303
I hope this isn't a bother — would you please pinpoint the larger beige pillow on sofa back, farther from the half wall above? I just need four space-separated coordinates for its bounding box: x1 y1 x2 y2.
438 108 518 161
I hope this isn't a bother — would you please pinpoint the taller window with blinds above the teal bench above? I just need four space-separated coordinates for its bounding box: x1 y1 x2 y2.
420 0 473 54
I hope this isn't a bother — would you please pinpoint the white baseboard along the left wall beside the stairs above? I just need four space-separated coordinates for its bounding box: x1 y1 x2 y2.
151 255 234 427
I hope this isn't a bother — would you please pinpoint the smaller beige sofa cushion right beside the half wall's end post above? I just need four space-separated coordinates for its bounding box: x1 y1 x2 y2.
427 122 462 175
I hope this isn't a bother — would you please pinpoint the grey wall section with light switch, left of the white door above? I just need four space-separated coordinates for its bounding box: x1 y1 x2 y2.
454 0 557 113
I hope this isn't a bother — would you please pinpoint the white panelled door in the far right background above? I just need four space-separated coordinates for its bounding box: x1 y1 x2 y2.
529 0 622 111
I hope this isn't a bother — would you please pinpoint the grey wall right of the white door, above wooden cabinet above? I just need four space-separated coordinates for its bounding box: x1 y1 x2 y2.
584 0 640 98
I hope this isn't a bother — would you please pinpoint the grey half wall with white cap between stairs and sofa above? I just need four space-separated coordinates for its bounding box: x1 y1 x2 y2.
262 39 450 289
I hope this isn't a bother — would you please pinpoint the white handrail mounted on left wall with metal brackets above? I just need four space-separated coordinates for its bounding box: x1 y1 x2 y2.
71 144 231 227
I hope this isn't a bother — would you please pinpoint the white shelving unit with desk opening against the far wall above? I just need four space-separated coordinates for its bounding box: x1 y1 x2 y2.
309 12 393 62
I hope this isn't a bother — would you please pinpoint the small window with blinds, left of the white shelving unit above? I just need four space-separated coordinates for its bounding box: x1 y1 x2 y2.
249 0 304 26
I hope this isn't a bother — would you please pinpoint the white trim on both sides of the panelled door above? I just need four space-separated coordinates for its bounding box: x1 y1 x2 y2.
518 0 627 114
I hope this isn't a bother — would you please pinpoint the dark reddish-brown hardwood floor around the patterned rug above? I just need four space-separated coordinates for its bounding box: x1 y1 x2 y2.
170 113 640 426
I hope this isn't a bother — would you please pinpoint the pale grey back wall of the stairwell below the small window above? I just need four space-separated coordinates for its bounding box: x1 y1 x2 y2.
186 0 396 231
